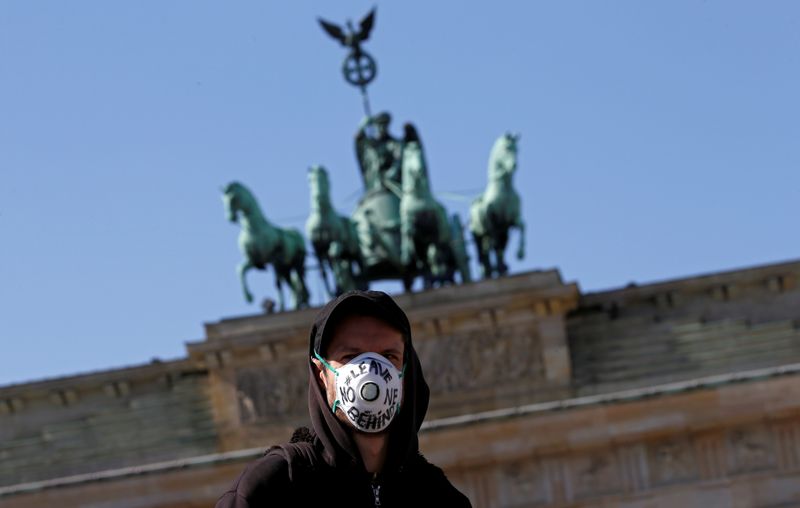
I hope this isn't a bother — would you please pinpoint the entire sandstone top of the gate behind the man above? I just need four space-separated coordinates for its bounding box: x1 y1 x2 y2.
0 262 800 508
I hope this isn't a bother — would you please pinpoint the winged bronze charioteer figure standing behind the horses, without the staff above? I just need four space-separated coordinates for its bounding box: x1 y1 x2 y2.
356 112 402 192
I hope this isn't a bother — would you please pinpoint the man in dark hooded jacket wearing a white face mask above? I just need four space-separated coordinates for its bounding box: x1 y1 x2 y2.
217 291 470 508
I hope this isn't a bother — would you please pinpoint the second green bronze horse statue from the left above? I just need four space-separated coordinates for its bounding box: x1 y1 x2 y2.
306 166 366 296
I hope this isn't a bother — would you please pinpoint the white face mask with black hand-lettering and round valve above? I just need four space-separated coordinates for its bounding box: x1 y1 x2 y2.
314 353 405 432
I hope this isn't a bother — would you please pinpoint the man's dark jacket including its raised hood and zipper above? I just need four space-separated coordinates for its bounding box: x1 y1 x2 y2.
217 291 470 508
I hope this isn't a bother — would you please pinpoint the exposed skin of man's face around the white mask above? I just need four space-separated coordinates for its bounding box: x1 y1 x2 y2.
312 316 405 425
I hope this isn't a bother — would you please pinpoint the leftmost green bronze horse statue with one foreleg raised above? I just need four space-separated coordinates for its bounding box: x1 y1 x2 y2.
222 182 308 310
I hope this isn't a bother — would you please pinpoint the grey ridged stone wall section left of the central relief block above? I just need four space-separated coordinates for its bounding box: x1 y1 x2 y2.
0 361 217 486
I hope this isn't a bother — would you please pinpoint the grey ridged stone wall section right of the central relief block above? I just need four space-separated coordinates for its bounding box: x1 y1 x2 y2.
567 263 800 394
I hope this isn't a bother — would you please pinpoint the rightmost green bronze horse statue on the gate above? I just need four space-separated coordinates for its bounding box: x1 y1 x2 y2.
469 133 525 278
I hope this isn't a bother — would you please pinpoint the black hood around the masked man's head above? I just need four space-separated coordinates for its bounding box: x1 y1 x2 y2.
308 291 430 472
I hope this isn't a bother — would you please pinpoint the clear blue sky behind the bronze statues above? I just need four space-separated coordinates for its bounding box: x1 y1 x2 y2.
0 0 800 384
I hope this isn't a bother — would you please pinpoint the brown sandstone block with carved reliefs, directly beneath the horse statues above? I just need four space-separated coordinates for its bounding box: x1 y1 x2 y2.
188 271 578 450
